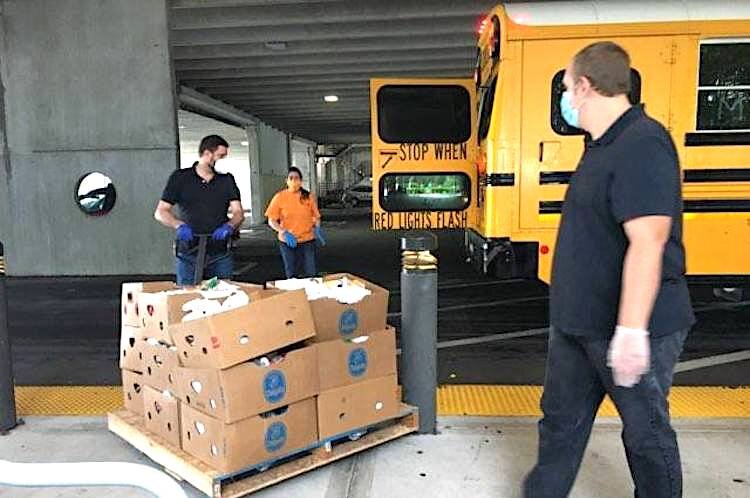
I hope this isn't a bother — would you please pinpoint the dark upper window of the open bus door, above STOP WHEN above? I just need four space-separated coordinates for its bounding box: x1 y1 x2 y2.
378 85 471 143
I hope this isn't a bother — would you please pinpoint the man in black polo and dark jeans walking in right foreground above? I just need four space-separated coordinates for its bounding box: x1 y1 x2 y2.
524 42 695 498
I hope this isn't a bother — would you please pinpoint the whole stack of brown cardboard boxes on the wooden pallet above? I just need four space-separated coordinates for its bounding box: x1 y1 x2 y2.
120 275 400 473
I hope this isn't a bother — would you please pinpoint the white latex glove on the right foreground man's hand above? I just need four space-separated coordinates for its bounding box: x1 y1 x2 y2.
607 325 651 387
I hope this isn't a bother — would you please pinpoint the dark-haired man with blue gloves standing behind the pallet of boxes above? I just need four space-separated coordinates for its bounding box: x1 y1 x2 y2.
154 135 245 285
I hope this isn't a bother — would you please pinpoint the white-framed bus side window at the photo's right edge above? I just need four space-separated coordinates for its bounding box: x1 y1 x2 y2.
696 40 750 131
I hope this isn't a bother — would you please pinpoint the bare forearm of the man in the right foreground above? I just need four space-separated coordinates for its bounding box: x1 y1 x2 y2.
617 242 664 330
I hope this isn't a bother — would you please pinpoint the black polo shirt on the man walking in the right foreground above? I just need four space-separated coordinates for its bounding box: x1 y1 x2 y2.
550 105 695 338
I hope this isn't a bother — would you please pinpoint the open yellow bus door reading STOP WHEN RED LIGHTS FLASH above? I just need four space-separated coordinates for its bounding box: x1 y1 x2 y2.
370 79 477 230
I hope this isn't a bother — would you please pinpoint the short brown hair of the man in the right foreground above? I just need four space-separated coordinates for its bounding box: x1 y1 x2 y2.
572 41 630 97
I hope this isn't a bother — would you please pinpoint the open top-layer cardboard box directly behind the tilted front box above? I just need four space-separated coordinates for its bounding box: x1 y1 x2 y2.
137 281 262 344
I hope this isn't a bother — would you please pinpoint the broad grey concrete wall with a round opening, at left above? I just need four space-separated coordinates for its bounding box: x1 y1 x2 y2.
0 0 177 276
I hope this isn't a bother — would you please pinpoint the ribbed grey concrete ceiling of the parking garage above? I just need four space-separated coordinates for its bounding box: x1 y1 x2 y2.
170 0 498 143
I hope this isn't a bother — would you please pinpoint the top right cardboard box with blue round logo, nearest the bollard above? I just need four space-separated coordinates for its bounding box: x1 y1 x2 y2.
269 273 389 342
